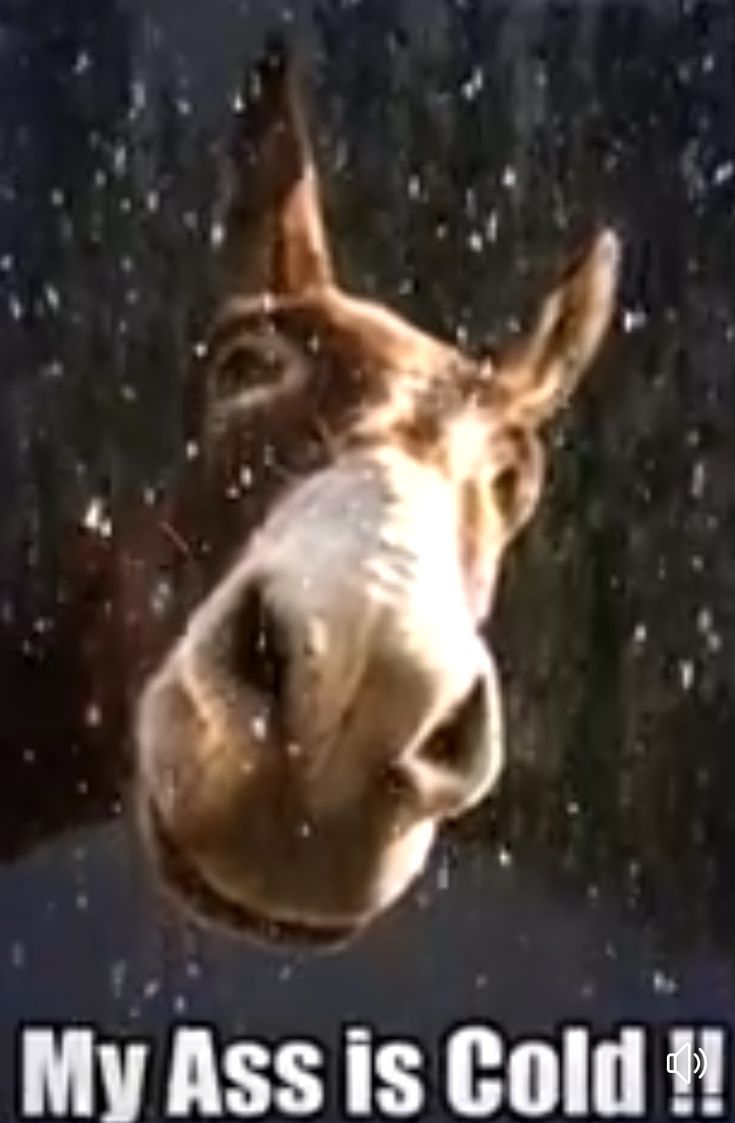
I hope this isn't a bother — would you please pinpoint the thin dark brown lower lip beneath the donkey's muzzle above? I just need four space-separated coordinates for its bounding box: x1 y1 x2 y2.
146 796 361 951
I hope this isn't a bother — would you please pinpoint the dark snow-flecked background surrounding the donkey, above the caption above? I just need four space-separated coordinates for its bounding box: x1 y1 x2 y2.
0 0 735 1117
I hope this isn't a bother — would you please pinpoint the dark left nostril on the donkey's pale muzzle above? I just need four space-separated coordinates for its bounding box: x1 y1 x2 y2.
228 585 288 706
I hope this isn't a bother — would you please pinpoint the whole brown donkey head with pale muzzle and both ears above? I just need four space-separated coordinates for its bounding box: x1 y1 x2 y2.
137 39 619 941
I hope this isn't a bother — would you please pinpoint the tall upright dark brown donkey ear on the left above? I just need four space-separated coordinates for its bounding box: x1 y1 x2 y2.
223 37 332 295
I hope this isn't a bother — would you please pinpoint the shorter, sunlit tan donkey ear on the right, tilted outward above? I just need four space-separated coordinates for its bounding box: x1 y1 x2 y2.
492 230 620 426
